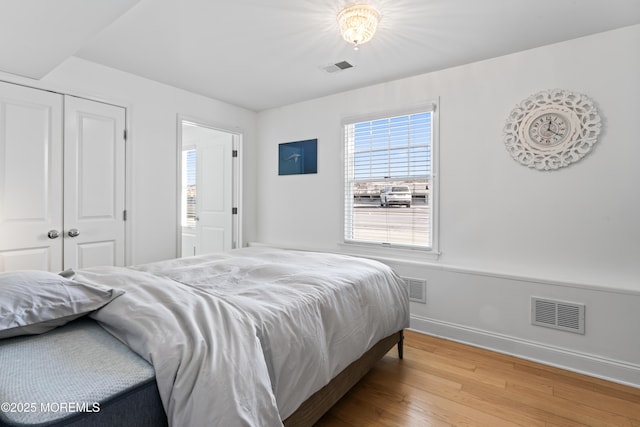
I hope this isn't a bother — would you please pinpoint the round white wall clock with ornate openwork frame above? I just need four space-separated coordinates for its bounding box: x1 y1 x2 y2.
504 89 602 170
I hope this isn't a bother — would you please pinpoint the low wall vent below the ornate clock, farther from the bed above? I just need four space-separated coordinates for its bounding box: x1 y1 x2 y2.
531 297 585 334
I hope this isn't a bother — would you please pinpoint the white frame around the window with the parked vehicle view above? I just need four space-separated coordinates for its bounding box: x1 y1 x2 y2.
340 100 440 261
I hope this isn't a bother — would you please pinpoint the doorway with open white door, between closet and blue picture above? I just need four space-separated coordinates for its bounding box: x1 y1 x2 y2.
178 118 242 257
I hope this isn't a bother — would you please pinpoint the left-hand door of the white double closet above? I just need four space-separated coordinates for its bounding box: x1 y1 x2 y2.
0 82 63 271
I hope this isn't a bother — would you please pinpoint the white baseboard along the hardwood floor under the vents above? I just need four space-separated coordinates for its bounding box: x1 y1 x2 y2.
410 315 640 388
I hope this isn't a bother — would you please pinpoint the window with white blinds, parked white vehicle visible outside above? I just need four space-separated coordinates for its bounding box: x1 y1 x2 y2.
344 107 434 249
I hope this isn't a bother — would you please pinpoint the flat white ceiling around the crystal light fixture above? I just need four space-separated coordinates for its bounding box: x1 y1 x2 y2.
0 0 640 111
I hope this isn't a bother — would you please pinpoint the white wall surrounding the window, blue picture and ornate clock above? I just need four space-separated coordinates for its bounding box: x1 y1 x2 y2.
255 26 640 386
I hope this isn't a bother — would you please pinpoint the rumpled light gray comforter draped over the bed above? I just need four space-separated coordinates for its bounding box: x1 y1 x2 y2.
80 248 409 427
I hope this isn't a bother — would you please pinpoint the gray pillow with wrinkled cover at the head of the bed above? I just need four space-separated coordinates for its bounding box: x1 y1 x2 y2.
0 271 124 339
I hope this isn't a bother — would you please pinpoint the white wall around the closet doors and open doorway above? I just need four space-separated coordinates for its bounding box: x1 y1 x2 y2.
0 57 256 264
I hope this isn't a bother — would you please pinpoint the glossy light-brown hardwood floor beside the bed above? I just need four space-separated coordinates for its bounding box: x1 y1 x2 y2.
316 331 640 427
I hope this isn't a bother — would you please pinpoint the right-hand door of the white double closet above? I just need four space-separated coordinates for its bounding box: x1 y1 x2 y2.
64 96 125 268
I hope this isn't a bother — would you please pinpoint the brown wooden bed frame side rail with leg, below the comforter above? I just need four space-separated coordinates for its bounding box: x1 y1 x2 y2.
283 331 404 427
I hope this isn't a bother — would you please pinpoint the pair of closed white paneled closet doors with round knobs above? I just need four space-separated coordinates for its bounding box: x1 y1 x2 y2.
0 82 126 272
